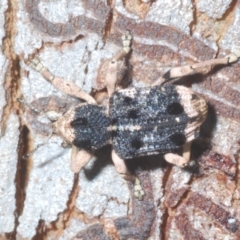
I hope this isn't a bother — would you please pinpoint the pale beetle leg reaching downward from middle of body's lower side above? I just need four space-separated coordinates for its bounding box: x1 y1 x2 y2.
112 150 145 200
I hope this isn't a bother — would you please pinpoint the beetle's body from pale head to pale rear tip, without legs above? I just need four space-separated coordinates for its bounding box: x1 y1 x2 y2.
53 85 207 159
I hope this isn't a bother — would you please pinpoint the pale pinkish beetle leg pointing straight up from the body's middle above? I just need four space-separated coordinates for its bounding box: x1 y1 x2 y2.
105 32 132 97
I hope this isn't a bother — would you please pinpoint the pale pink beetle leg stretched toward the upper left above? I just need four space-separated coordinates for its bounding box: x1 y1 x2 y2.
27 57 96 104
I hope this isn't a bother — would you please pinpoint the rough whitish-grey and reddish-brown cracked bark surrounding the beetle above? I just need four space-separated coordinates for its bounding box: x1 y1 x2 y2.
0 0 240 240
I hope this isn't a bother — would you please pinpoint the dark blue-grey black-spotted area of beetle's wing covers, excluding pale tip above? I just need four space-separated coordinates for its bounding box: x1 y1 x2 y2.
109 85 206 159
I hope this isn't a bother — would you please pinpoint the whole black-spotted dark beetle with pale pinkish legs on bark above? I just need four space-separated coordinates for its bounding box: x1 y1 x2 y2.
27 32 238 200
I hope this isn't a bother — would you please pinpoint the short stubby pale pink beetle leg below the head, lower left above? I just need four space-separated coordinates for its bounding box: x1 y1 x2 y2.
70 145 92 173
